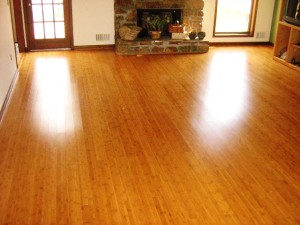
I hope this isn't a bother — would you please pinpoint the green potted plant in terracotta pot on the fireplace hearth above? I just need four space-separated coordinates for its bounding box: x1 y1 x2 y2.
145 15 167 39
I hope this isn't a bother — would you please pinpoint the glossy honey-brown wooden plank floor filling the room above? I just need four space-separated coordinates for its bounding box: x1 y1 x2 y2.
0 46 300 225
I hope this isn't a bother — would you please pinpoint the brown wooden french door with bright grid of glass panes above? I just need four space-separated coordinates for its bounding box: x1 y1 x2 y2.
25 0 72 50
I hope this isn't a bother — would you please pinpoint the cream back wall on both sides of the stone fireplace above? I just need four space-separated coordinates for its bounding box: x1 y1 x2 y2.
72 0 275 46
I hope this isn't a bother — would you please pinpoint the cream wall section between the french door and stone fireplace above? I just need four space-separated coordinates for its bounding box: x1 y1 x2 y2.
72 0 115 46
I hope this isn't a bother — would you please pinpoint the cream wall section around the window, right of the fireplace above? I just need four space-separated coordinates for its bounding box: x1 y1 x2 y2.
202 0 275 42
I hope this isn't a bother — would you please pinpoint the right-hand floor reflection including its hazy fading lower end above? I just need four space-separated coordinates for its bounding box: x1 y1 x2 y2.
191 51 249 151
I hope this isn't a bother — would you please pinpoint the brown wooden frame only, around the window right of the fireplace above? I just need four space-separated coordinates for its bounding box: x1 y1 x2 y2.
213 0 259 37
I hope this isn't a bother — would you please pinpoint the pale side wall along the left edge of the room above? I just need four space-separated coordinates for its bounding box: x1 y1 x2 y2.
0 0 17 109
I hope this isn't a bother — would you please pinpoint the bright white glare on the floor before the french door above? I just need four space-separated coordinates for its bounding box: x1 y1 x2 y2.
34 58 75 133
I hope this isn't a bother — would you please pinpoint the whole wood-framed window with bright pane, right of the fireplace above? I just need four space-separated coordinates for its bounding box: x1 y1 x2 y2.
214 0 258 37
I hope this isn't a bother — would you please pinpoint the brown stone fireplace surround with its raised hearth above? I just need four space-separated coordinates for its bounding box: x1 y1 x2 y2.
115 0 209 55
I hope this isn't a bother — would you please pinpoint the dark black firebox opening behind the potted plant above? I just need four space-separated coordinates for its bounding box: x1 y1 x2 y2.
137 9 183 38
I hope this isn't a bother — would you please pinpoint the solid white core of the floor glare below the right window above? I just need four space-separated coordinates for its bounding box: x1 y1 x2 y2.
203 52 248 126
